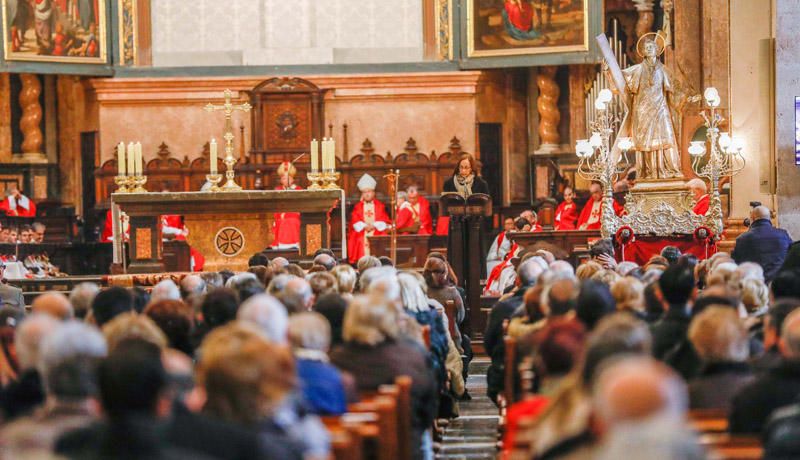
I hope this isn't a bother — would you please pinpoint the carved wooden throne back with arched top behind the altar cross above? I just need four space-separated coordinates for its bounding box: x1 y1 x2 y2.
248 77 325 164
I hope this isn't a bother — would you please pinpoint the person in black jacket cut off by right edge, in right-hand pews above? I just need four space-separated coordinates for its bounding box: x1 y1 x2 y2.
728 310 800 433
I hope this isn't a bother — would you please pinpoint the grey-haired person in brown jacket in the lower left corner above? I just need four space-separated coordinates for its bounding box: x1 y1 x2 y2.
0 321 106 452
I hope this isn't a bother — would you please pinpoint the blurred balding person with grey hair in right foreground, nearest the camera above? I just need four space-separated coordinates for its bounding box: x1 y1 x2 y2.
593 356 706 460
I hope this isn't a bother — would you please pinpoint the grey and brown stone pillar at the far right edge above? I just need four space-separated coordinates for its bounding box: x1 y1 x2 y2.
772 0 800 239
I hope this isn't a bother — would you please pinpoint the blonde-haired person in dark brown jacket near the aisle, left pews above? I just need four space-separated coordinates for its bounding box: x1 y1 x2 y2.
331 296 437 458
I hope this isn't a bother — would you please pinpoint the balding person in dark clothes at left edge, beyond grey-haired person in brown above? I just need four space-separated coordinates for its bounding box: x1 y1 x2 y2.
2 314 61 420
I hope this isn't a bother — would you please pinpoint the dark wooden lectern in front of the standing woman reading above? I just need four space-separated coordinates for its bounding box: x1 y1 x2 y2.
439 193 492 336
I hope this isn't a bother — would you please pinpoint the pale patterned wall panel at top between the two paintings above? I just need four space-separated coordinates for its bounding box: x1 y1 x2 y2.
151 0 423 67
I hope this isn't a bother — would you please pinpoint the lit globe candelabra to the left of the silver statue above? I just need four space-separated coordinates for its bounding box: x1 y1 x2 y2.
575 89 633 238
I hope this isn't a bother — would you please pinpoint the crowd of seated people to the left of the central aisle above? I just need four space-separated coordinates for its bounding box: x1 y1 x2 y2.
0 246 470 459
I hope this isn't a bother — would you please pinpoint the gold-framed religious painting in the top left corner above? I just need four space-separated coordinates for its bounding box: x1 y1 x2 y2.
0 0 107 64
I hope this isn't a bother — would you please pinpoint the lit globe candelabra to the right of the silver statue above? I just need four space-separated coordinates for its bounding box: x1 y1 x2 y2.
689 87 746 235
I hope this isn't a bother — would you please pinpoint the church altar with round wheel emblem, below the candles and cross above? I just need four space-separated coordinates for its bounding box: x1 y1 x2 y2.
111 190 347 273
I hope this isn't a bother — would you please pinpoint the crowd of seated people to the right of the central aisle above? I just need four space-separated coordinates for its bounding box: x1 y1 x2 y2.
484 209 800 459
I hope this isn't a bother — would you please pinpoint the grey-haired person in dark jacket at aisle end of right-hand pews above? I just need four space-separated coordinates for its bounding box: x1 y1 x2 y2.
483 259 544 403
